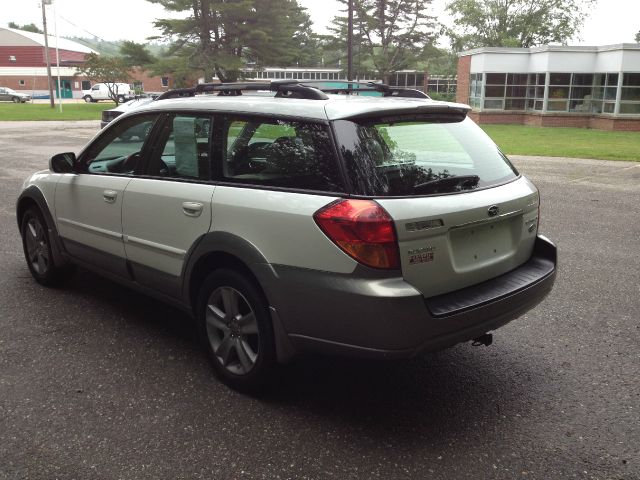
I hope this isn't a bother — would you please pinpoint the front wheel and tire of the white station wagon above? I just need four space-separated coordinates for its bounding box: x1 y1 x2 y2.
20 207 73 287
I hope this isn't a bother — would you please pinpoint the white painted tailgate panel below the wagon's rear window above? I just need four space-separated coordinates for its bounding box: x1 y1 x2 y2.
378 178 538 297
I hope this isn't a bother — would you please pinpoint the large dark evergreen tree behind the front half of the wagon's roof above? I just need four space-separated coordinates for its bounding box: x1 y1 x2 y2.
148 0 311 81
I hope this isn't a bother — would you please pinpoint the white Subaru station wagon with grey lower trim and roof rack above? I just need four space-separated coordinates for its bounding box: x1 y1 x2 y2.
17 82 556 390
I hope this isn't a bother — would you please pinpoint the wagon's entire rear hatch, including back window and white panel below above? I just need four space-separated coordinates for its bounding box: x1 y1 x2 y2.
335 113 539 298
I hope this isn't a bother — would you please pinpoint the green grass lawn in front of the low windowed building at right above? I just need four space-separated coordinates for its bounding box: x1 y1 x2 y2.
482 125 640 162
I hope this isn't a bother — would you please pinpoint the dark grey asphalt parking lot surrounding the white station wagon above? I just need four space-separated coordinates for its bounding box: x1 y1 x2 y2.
0 122 640 480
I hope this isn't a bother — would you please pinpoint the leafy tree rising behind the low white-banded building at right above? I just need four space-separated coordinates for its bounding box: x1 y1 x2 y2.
447 0 595 51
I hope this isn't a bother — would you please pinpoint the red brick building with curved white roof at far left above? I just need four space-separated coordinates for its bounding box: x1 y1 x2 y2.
0 28 173 98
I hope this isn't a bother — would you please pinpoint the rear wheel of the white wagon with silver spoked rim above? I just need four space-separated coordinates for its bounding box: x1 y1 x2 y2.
197 269 276 393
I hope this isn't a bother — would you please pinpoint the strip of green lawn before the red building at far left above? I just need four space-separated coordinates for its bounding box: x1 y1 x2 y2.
0 102 116 121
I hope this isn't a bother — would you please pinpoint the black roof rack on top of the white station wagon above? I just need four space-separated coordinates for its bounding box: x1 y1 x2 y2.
157 80 429 100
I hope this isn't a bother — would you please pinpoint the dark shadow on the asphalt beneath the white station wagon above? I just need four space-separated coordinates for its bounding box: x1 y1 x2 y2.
58 266 545 444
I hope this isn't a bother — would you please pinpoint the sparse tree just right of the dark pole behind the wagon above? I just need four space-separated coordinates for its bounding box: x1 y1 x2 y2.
334 0 436 83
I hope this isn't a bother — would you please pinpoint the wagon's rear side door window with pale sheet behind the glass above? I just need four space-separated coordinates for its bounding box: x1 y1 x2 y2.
149 115 211 180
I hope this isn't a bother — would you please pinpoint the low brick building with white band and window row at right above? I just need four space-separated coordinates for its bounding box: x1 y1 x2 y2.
457 44 640 131
